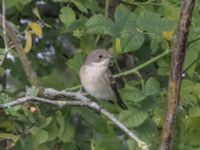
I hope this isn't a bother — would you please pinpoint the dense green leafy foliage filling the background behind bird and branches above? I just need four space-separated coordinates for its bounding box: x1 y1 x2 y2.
0 0 200 150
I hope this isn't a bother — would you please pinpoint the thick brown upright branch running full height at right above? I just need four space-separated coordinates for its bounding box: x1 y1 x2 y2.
160 0 195 150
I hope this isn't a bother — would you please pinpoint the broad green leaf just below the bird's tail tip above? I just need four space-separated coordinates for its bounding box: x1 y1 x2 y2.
119 108 147 128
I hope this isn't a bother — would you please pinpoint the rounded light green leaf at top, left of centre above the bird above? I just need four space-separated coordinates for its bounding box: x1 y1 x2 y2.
59 7 76 27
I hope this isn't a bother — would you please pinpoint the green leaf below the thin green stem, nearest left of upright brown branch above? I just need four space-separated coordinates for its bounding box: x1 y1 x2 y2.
144 77 160 95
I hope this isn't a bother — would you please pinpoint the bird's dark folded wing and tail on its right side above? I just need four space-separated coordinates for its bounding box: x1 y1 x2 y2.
105 69 128 110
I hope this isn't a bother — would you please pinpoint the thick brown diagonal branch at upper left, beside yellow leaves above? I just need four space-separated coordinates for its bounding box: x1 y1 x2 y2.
0 14 40 87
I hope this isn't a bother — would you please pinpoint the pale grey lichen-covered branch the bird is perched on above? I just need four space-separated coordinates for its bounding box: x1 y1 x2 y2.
0 89 148 150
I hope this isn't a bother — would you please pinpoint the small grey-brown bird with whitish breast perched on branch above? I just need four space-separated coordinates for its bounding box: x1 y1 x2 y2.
79 49 128 110
